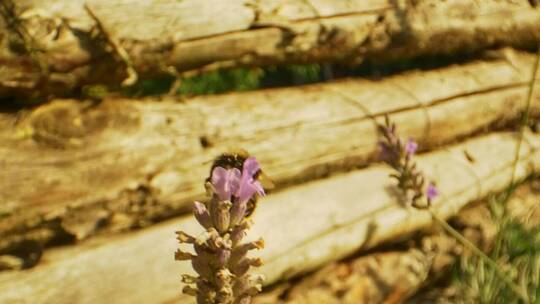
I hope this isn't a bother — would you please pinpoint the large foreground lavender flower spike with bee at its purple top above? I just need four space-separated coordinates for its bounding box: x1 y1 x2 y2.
175 154 265 304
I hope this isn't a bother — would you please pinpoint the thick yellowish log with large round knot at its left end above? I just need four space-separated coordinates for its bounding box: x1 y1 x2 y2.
0 49 540 253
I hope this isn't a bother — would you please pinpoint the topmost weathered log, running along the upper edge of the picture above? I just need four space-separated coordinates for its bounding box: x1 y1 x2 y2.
0 0 540 97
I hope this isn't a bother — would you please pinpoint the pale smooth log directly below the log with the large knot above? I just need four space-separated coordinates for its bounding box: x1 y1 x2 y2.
0 133 540 304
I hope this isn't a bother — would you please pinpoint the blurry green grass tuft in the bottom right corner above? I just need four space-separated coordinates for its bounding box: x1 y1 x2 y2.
453 198 540 304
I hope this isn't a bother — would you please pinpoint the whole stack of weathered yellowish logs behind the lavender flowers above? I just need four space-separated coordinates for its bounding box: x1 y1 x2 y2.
0 0 540 304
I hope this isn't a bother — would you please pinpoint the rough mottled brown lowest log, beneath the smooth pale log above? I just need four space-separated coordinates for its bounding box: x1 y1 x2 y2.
254 179 540 304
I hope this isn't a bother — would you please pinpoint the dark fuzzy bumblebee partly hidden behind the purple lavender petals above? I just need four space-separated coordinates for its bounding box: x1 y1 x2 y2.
206 149 274 218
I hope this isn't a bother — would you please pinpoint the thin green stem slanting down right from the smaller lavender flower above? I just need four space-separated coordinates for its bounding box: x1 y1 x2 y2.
428 209 530 303
